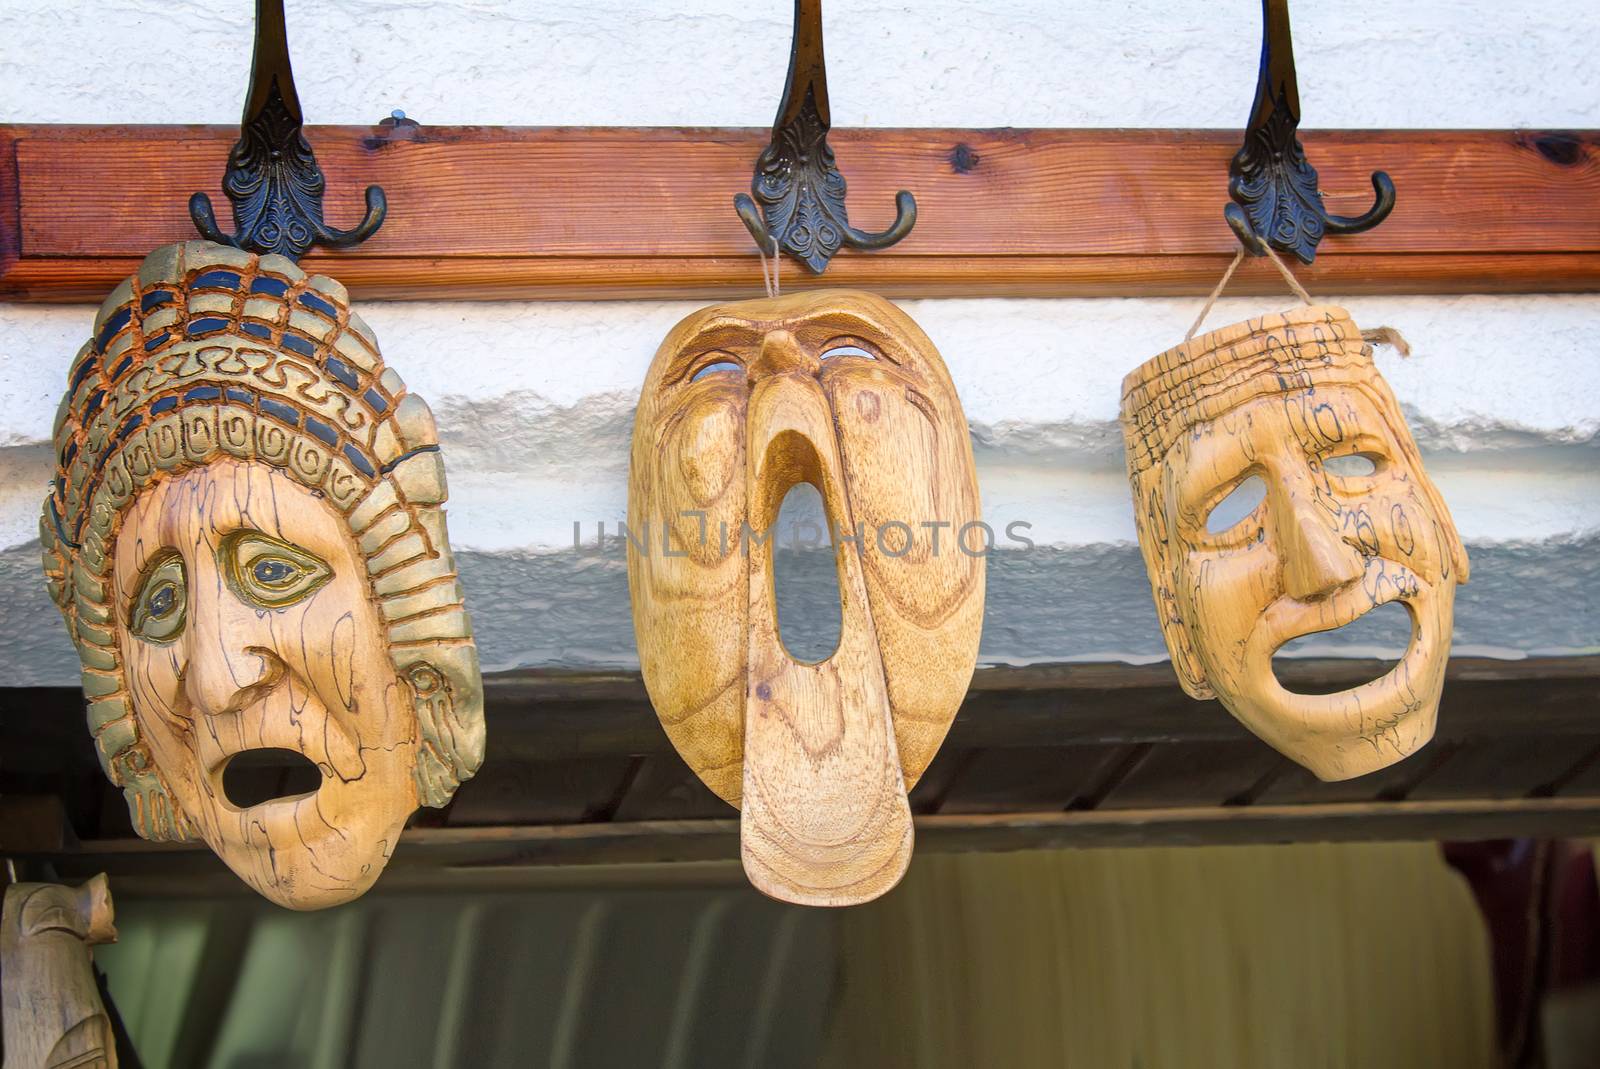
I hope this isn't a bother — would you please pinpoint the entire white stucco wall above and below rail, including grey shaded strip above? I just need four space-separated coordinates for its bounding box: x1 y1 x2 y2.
0 0 1600 685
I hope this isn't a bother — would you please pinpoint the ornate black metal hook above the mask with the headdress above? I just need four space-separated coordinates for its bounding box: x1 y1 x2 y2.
189 0 389 261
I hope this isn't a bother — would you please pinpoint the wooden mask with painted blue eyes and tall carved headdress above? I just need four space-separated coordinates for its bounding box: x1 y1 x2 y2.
40 242 483 909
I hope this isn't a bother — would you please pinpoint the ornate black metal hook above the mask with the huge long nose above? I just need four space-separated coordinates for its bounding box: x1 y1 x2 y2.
733 0 917 275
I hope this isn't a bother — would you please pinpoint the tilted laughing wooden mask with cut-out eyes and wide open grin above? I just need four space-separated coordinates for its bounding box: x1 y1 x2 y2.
1122 306 1467 779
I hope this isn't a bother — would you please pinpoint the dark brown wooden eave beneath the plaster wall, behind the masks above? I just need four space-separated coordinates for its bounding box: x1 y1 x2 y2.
0 656 1600 891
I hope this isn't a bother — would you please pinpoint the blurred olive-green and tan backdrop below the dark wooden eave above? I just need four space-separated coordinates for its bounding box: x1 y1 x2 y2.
96 843 1494 1069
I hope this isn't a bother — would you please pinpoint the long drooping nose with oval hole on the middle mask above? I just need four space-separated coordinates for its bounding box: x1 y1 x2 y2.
739 364 914 906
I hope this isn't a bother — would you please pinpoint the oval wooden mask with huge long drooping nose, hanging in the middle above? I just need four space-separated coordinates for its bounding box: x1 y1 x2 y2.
627 291 984 906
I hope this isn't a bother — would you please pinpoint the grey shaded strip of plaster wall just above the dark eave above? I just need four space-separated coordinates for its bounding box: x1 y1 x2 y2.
0 528 1600 687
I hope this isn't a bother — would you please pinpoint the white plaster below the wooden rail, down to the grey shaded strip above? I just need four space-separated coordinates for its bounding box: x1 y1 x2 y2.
0 296 1600 552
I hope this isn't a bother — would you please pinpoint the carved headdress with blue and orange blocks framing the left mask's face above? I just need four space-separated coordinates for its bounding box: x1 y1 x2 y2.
40 242 483 839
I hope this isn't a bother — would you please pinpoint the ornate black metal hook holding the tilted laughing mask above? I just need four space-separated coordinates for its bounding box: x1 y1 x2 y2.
1224 0 1395 264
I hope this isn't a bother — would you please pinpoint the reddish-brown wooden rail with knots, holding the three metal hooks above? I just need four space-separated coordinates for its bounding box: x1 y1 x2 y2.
0 125 1600 301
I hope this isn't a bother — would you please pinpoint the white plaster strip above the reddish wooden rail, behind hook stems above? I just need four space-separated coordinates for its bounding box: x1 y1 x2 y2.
0 0 1600 128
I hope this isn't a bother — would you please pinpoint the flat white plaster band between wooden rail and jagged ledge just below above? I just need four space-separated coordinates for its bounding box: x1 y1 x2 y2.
15 296 1600 457
